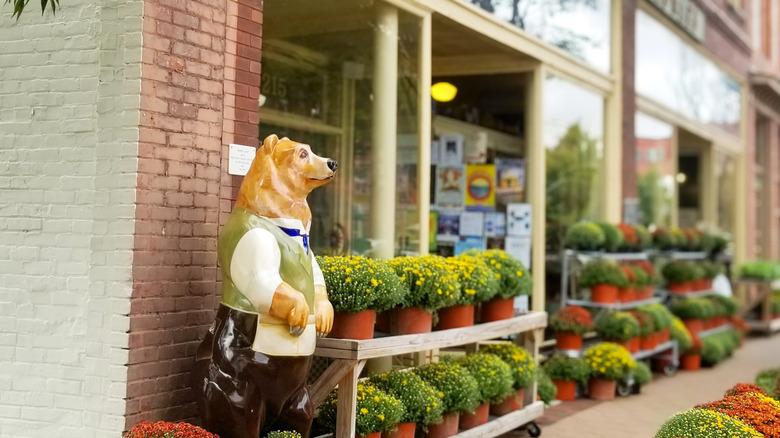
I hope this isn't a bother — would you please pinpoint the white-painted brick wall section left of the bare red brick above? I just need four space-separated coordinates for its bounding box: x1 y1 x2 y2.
0 0 143 438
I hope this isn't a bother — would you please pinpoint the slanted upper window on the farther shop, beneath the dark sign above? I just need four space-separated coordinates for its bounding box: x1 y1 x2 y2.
635 11 741 135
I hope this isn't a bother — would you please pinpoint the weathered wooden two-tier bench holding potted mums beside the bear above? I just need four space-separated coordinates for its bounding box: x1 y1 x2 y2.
311 312 547 438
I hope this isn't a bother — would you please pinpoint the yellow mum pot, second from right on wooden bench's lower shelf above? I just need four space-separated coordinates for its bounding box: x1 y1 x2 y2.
458 351 515 429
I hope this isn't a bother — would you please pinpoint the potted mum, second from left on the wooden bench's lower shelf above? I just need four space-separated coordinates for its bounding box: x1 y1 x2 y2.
370 370 444 438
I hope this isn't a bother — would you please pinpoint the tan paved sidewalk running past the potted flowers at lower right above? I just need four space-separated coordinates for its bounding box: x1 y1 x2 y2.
504 335 780 438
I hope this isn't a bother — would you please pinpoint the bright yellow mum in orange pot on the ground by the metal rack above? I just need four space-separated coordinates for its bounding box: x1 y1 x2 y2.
585 342 636 400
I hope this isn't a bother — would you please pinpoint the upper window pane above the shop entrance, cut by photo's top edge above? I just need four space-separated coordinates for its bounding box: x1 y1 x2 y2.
463 0 611 72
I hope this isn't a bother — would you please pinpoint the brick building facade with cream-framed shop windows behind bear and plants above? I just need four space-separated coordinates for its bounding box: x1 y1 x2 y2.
0 0 780 437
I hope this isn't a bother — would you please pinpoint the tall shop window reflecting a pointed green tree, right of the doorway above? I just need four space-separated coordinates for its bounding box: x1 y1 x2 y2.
543 76 608 248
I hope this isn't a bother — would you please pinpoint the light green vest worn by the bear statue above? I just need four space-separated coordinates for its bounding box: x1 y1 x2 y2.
217 207 314 314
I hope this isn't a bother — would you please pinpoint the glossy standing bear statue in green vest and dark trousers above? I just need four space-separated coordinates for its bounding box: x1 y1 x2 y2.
192 135 338 438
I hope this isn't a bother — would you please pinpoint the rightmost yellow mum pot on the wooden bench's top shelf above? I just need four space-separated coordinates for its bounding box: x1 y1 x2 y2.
468 249 533 322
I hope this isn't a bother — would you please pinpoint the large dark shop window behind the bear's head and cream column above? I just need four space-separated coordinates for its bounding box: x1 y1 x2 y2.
260 0 421 255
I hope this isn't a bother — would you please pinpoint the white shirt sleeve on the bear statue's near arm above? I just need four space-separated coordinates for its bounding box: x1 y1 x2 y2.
230 228 282 313
